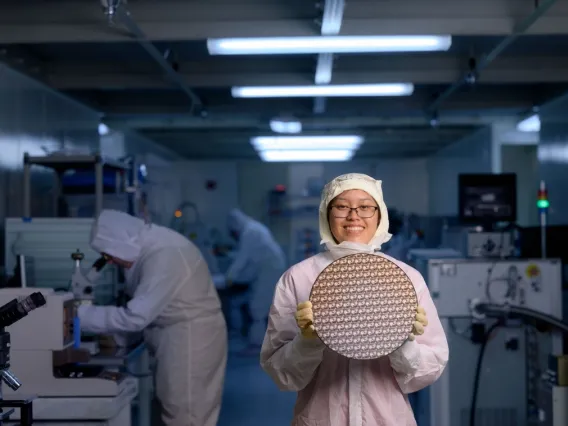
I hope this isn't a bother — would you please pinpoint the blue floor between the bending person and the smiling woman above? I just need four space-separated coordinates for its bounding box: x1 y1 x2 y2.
217 338 296 426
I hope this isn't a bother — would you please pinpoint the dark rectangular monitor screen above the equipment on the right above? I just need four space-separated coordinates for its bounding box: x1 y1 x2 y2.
459 173 517 225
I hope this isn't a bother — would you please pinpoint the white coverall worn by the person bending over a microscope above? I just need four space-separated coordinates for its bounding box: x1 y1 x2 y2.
78 210 227 426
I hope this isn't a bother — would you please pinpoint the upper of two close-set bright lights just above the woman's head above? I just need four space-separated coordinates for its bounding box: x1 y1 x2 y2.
250 135 363 151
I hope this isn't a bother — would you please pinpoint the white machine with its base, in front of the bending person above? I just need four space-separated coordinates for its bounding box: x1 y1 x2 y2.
0 288 138 426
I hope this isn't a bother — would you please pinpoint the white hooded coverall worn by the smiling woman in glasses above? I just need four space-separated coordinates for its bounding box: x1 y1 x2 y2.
261 174 448 426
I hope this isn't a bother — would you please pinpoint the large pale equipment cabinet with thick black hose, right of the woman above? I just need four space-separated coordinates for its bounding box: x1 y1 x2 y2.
426 259 562 426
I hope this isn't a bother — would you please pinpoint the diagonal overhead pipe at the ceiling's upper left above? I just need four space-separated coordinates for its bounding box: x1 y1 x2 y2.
102 0 203 113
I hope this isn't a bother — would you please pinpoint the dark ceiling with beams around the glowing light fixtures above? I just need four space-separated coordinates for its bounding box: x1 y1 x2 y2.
0 0 568 159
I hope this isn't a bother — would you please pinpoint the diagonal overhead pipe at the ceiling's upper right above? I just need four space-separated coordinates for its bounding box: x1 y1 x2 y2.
426 0 557 113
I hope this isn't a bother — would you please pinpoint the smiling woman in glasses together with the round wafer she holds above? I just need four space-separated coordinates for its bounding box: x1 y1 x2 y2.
261 174 448 426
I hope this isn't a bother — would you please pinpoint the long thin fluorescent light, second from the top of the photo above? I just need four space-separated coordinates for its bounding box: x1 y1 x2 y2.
231 83 414 98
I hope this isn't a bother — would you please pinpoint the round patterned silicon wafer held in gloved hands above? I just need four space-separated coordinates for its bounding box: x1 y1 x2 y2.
310 253 418 359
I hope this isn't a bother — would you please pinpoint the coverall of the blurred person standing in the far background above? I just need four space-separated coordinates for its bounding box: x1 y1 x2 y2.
227 209 286 346
